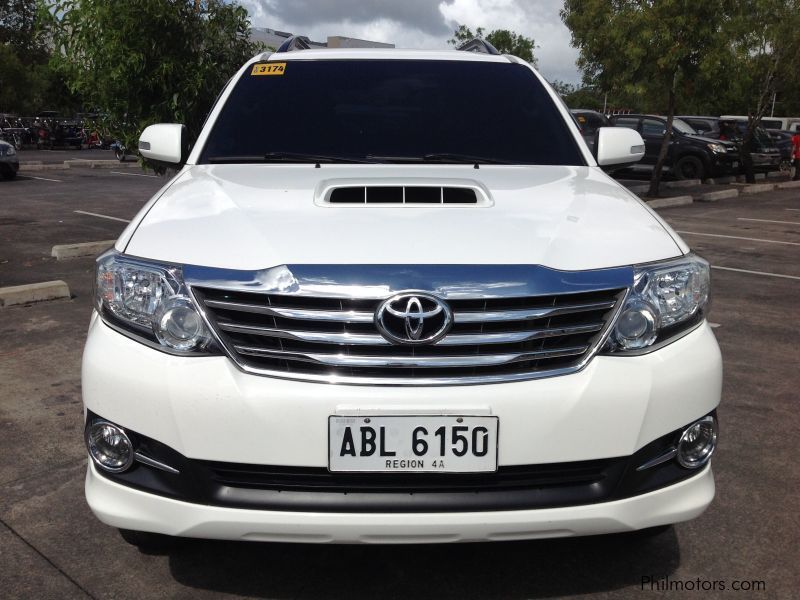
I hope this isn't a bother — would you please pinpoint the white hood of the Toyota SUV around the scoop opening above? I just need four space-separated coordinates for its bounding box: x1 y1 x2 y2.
122 164 682 270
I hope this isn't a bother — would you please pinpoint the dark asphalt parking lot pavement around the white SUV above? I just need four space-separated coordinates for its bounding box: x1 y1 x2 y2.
0 170 800 599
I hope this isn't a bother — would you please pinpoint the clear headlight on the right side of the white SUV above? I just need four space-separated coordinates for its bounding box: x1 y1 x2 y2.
604 255 711 353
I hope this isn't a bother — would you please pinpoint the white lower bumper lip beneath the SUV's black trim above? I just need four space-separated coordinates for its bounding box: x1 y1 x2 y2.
86 463 714 544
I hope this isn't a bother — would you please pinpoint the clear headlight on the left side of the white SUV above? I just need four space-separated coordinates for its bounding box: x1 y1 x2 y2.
95 250 216 354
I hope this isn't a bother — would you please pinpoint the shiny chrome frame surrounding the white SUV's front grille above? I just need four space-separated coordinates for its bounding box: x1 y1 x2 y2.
183 265 634 387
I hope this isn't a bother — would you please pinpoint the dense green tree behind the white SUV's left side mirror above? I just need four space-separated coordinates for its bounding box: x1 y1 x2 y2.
40 0 261 148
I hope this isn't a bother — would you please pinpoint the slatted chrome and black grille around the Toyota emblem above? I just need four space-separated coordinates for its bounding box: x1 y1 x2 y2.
193 276 627 384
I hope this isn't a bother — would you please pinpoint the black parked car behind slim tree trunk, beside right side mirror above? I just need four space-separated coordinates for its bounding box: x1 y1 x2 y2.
610 114 739 179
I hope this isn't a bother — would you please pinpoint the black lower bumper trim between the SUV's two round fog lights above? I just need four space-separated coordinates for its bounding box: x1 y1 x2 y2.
87 413 712 513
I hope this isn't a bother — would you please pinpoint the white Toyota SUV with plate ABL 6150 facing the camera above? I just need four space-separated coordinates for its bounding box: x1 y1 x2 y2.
83 44 722 543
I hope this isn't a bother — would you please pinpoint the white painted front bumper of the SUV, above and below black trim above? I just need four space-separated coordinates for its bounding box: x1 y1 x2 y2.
83 316 721 542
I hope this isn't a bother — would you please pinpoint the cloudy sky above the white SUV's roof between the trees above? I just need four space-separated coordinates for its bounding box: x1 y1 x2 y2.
239 0 580 83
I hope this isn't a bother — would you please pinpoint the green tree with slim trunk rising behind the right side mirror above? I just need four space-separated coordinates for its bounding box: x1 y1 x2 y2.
561 0 732 196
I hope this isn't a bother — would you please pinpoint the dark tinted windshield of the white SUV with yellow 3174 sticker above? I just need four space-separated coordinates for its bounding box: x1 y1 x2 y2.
200 55 586 165
